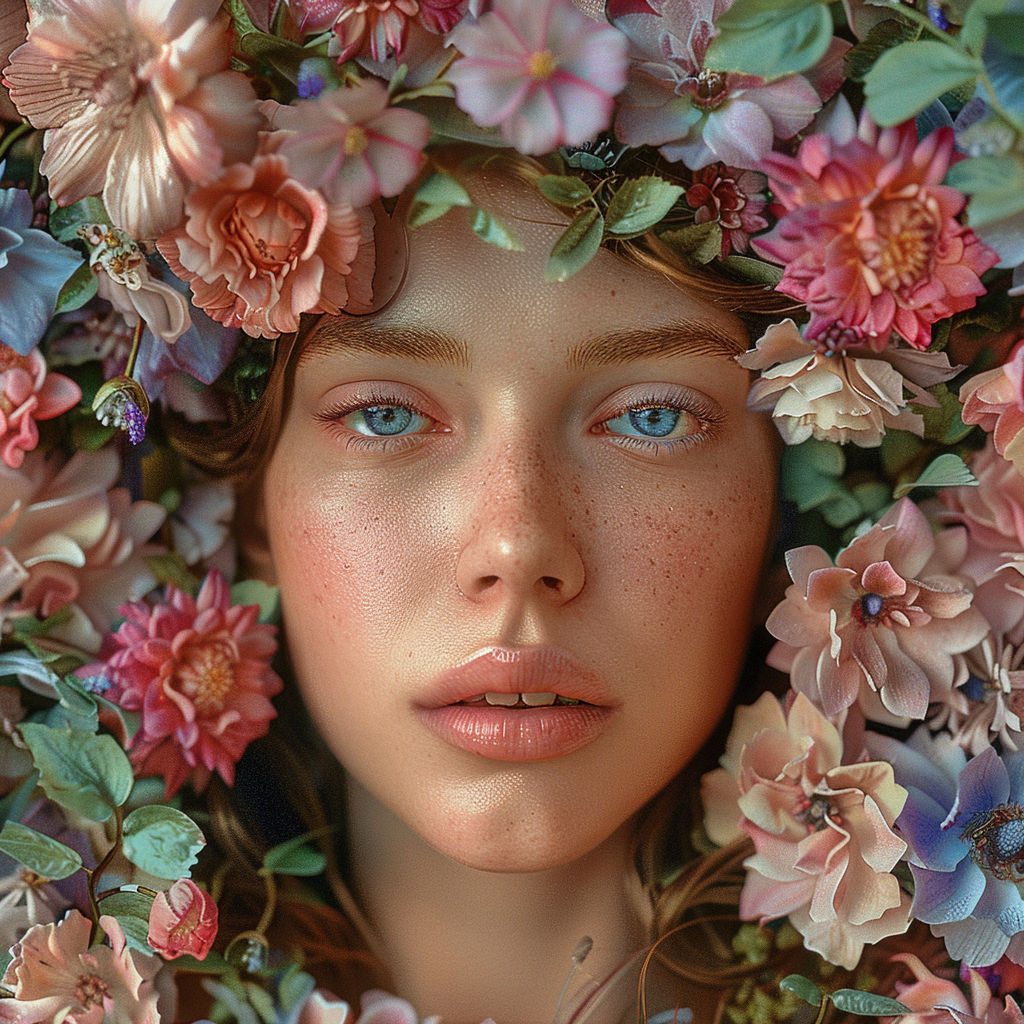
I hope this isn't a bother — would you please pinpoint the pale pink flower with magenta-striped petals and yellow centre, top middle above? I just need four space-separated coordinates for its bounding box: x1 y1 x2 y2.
447 0 627 154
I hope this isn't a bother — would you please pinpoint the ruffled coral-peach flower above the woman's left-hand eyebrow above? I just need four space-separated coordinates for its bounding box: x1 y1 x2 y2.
157 155 373 338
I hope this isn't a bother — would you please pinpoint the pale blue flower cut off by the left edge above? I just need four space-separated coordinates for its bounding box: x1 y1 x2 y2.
0 184 82 355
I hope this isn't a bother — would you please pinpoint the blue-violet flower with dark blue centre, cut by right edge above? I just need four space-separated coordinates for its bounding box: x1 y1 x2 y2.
870 729 1024 967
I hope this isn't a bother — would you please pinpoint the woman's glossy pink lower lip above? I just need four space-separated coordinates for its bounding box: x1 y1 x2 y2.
420 705 615 761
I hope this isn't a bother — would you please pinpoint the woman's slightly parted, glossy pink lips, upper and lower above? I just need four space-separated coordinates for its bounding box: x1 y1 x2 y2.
417 646 618 762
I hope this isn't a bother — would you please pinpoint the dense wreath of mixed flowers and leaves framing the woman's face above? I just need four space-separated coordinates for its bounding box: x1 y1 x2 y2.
0 0 1024 1024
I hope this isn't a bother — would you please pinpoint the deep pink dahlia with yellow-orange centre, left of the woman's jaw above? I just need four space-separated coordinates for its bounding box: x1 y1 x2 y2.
95 569 283 798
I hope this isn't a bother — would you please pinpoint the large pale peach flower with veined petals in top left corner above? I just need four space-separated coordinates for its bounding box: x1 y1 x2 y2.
4 0 259 240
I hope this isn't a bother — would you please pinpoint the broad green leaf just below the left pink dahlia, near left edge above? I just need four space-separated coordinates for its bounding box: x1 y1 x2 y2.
18 722 133 821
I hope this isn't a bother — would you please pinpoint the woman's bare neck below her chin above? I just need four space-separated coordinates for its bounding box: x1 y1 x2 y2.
348 780 647 1024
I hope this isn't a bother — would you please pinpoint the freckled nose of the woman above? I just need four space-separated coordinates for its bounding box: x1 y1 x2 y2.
456 438 586 605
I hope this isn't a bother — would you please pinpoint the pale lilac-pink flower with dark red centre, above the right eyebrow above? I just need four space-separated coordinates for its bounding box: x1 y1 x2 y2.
607 0 849 170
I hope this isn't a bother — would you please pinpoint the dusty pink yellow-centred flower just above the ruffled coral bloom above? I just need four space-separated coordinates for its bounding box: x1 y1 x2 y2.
265 79 430 206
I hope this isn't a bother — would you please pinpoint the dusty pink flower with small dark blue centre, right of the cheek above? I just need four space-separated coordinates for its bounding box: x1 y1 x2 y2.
766 499 988 720
